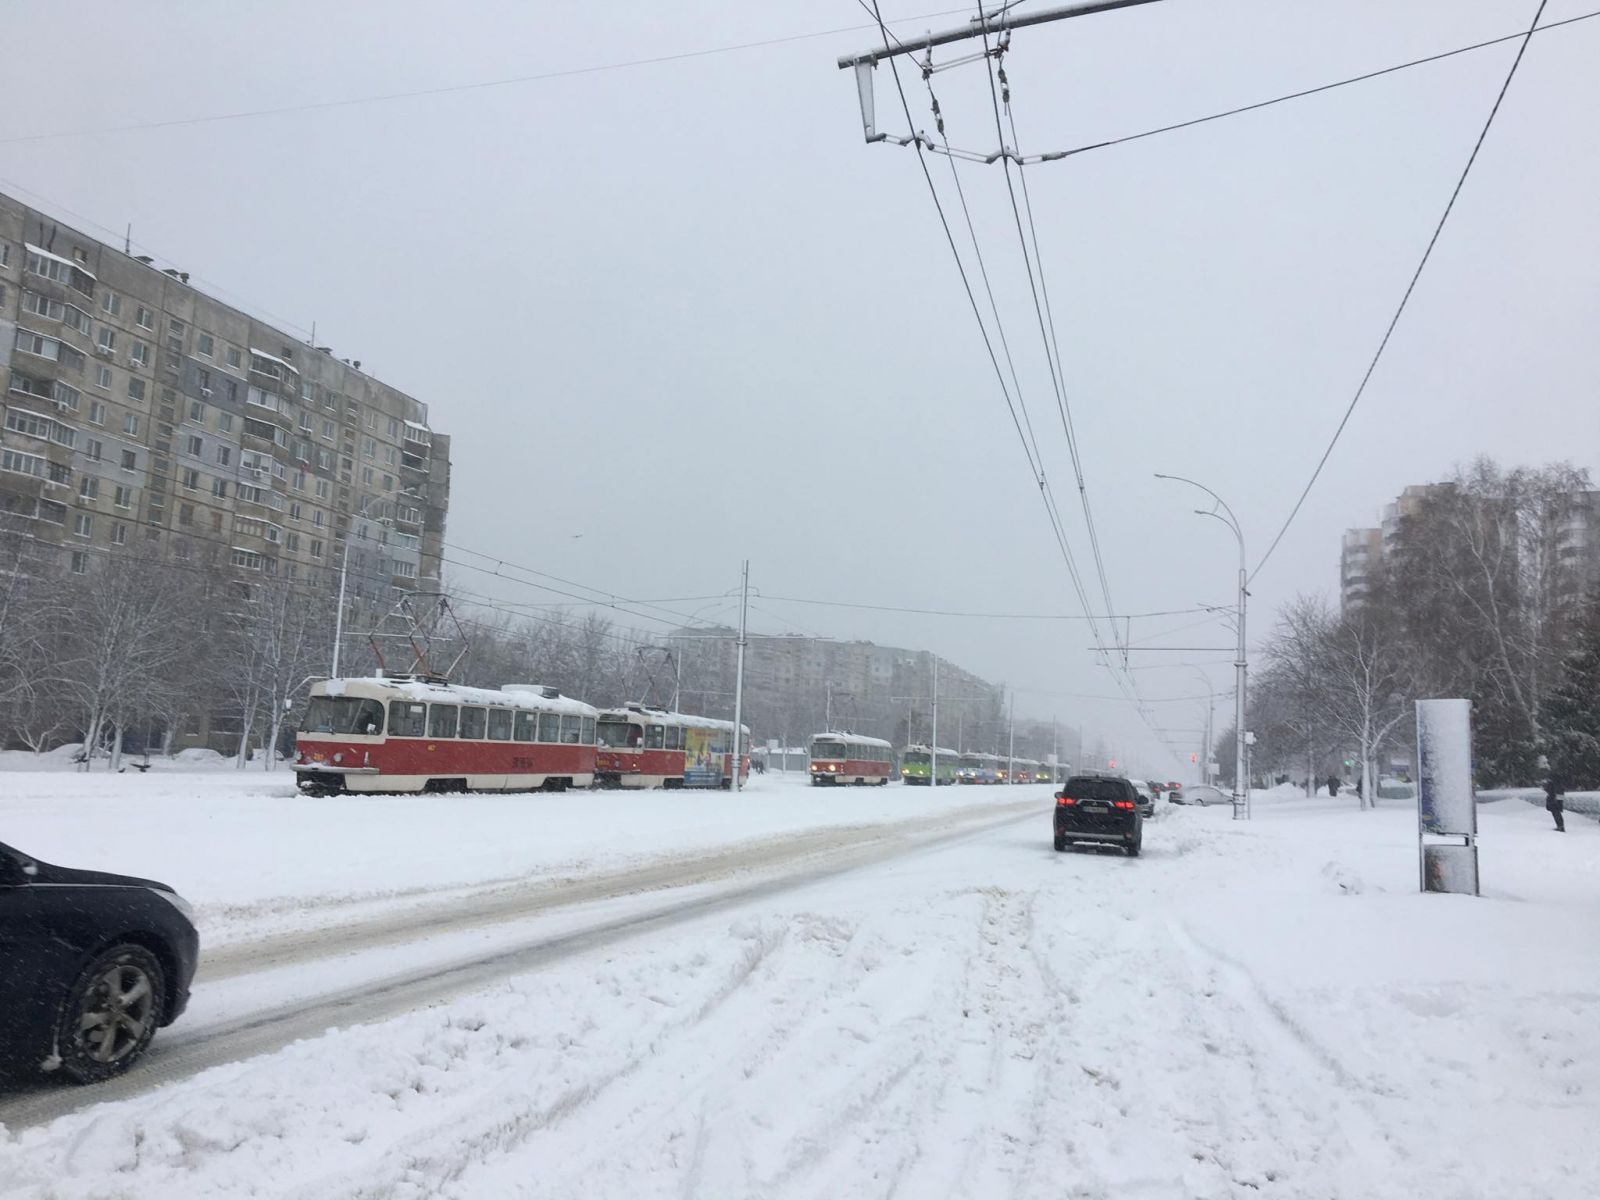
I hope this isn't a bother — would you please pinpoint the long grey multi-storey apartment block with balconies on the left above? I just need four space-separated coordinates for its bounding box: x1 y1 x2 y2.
0 195 450 605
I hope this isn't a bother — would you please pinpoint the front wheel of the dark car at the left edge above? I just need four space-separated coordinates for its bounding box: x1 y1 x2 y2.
56 946 166 1083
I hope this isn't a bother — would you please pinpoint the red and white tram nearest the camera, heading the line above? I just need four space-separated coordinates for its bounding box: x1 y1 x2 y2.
294 675 600 795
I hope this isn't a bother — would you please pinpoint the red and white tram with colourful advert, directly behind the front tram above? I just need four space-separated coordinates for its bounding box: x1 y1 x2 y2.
595 704 750 787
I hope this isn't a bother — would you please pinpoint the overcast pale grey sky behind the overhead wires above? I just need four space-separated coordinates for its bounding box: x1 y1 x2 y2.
0 0 1600 774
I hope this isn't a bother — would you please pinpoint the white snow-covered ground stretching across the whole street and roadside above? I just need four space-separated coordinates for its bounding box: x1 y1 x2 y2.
0 773 1600 1200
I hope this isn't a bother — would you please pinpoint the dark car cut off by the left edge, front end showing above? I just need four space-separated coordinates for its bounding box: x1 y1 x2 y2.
0 843 200 1083
